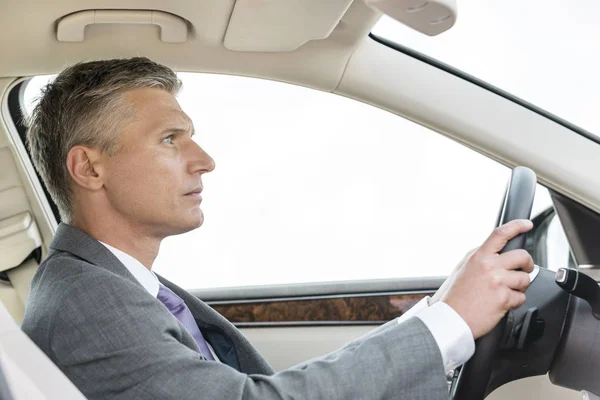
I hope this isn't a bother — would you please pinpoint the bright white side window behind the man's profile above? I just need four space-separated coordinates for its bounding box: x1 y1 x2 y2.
25 73 551 288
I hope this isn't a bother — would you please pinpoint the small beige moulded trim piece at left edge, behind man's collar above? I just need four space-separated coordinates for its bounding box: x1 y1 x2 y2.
0 212 42 272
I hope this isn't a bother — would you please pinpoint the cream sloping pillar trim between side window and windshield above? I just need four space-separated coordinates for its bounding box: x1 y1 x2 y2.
335 38 600 216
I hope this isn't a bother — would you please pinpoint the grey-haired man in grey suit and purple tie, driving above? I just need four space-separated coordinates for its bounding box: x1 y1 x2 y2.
23 58 533 400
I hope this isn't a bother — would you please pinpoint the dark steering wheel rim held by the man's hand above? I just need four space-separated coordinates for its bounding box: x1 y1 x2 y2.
450 167 537 400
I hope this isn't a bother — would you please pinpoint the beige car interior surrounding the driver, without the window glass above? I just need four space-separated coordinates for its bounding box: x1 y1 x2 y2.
0 0 600 400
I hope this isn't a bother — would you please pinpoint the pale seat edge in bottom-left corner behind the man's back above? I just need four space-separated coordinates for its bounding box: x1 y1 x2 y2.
0 303 85 400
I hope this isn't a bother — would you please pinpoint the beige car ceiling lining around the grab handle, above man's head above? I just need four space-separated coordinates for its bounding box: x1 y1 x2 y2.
0 0 380 90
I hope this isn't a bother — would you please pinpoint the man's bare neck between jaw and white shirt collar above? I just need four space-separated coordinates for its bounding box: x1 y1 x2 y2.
70 212 162 270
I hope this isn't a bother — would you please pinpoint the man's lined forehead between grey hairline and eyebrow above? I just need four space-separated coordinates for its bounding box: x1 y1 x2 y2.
120 88 192 129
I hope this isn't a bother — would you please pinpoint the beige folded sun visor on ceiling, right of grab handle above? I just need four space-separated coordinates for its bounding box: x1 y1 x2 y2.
224 0 353 52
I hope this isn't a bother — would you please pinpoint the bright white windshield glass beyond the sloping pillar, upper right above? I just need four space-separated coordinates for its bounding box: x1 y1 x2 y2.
372 0 600 136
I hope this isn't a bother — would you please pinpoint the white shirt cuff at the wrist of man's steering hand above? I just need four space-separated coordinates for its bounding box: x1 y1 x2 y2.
416 301 475 372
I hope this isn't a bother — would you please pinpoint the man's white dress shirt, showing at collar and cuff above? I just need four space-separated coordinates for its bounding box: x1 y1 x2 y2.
100 242 475 372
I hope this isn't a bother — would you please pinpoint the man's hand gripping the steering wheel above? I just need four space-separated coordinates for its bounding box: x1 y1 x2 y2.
430 220 533 339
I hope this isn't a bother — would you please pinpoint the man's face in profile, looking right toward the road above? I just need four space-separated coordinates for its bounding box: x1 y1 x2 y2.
104 88 215 237
